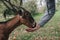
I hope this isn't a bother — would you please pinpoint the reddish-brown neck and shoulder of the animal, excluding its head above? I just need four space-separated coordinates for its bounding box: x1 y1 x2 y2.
0 15 20 40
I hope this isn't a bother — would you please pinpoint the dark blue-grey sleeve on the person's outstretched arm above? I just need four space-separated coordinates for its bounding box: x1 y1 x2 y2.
39 0 55 27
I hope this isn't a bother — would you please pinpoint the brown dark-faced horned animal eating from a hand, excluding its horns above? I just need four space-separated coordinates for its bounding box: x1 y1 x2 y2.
0 10 36 40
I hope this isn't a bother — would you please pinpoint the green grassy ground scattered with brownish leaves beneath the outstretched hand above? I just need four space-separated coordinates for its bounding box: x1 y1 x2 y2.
9 10 60 40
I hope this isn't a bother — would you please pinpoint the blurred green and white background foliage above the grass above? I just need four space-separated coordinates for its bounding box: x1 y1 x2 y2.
0 0 60 15
